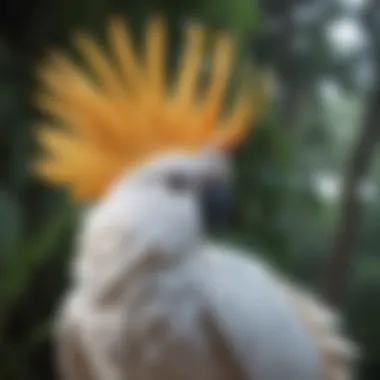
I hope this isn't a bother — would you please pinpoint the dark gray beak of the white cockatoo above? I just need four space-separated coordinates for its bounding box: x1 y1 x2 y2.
202 181 236 232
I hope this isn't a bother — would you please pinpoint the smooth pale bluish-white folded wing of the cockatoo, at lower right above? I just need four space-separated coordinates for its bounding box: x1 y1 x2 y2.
199 246 321 380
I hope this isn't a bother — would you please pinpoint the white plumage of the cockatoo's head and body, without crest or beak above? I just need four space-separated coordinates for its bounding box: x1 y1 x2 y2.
57 148 355 380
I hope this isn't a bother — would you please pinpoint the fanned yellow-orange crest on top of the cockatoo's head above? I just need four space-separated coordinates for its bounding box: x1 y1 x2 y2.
35 17 270 201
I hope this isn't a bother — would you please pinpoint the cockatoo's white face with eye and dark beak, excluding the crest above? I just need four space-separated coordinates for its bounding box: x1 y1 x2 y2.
86 149 232 252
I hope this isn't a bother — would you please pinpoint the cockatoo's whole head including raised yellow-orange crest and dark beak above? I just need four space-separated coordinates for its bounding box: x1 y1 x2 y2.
36 17 270 262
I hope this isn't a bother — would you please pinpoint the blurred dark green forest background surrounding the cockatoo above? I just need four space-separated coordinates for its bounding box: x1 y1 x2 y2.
0 0 380 380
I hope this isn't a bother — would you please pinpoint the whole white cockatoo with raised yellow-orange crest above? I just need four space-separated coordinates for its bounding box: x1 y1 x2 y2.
36 13 356 380
